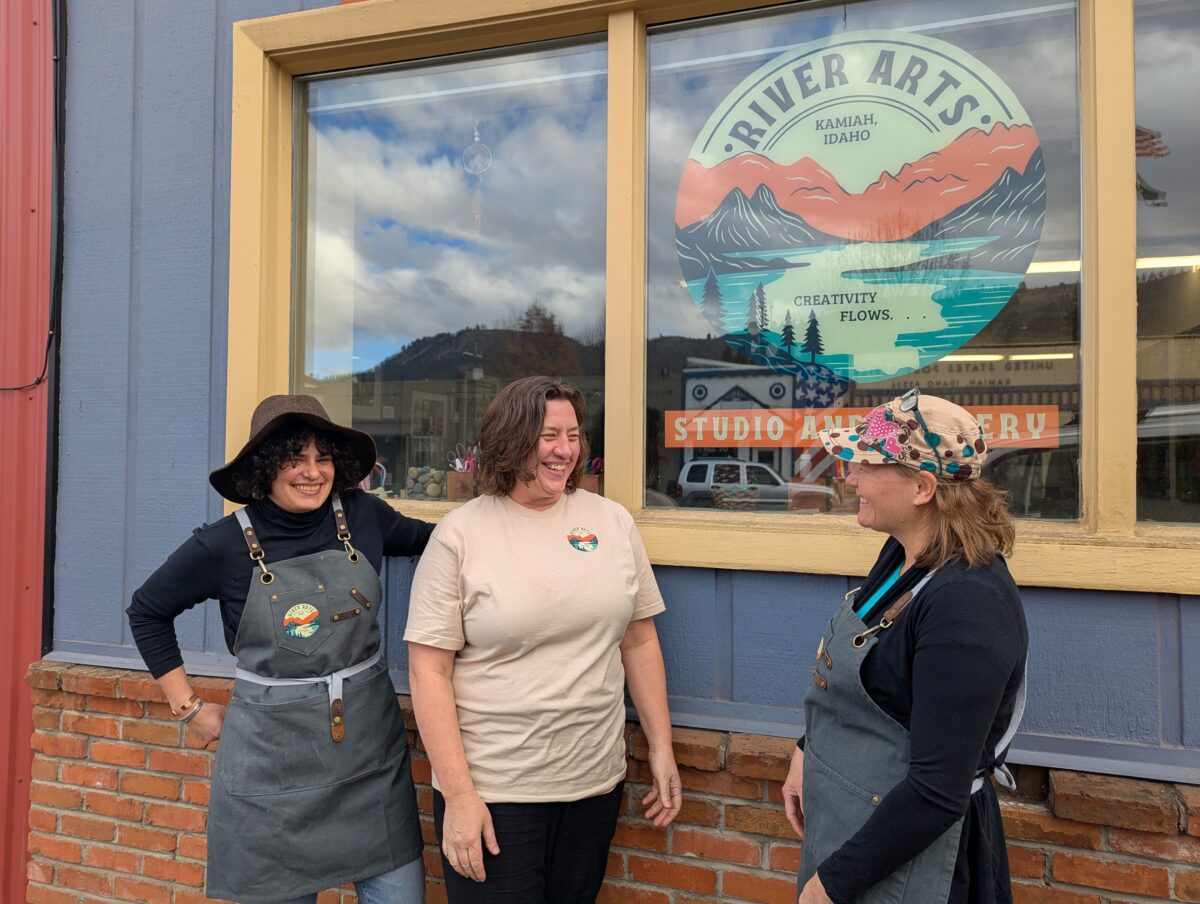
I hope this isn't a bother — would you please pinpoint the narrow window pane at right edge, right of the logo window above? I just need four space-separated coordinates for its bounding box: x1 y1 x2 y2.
1134 0 1200 523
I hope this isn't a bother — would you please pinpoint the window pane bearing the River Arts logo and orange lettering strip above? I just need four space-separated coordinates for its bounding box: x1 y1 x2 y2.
646 0 1080 520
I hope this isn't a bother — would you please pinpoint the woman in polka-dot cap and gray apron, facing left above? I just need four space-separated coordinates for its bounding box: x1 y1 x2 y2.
784 389 1028 904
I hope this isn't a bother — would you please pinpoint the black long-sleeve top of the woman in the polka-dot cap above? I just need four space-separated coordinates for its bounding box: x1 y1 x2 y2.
817 539 1028 904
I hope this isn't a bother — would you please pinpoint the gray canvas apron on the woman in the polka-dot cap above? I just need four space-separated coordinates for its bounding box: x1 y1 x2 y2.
799 571 1025 904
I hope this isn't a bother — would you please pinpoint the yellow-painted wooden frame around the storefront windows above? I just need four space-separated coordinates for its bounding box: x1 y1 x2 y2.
226 0 1200 593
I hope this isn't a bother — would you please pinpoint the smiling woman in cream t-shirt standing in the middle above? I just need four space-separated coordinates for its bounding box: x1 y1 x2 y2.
404 377 680 904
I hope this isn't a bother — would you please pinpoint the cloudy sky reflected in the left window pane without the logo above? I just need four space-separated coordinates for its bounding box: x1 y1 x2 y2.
298 41 607 376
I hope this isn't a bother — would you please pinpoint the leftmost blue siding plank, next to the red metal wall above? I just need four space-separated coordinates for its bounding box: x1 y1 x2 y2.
54 4 136 654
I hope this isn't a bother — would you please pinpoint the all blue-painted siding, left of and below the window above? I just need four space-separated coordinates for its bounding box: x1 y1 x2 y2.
46 0 1200 782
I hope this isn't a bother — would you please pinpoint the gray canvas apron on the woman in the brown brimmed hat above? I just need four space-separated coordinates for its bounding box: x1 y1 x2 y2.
206 495 424 902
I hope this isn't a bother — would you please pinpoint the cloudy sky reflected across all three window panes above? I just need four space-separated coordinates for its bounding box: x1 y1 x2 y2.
298 0 1200 375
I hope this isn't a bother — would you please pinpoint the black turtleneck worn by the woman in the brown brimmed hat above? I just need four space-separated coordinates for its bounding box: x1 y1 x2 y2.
126 490 433 678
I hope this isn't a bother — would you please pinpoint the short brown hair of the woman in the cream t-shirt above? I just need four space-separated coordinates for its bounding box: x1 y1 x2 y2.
475 377 588 496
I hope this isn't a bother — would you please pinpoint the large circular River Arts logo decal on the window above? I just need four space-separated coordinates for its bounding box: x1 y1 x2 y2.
676 31 1045 383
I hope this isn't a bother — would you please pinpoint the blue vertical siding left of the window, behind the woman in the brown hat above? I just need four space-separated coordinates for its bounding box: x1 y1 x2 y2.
54 0 334 666
